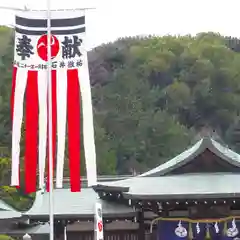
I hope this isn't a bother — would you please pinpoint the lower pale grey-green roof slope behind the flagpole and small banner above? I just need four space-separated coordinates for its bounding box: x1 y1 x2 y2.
23 188 135 219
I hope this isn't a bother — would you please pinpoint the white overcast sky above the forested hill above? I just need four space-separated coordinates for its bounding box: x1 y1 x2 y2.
0 0 240 48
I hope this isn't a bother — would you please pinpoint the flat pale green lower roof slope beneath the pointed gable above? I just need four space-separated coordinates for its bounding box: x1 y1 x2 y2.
122 173 240 200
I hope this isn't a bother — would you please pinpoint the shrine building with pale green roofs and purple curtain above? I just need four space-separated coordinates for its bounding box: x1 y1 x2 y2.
0 136 240 240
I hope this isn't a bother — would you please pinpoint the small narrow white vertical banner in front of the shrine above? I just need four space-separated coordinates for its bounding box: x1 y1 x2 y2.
94 200 103 240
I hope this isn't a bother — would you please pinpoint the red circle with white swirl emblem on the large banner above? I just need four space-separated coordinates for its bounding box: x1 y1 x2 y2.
37 34 60 61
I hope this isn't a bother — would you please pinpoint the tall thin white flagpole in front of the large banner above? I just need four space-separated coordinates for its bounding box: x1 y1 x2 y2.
47 0 54 240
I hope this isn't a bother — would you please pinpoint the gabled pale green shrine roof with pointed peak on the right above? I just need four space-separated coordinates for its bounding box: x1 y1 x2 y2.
94 136 240 200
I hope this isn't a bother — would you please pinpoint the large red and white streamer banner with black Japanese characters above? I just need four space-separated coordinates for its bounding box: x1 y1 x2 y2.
11 10 96 193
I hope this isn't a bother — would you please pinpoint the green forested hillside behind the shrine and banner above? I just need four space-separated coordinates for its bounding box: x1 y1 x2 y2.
0 28 240 208
